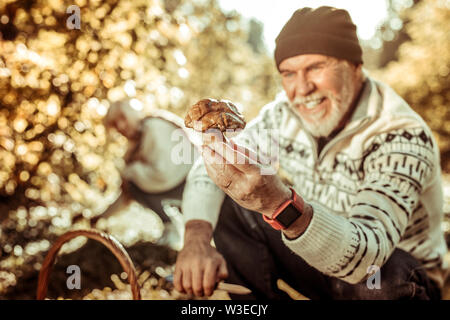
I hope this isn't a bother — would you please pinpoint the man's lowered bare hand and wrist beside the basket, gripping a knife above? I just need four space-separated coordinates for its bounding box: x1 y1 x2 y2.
173 220 228 297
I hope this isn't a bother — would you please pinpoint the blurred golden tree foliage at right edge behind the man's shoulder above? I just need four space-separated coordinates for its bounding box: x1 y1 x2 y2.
373 0 450 172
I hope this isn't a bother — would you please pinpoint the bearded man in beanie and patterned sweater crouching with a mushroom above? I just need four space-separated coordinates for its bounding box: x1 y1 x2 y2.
174 7 447 299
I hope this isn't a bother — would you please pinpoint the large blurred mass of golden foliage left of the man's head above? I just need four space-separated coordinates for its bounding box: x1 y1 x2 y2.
0 0 277 220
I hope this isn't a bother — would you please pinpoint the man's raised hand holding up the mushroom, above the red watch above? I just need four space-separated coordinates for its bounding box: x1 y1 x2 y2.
203 142 291 218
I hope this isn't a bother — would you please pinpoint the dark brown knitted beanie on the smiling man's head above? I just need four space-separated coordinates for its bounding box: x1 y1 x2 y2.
275 7 362 69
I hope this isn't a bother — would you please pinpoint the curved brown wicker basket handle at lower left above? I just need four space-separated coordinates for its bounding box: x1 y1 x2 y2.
36 229 141 300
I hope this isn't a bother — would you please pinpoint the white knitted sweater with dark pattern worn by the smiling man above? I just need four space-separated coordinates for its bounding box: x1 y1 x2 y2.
182 77 447 283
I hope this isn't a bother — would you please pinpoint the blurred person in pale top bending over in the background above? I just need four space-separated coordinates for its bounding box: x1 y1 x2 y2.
102 100 195 246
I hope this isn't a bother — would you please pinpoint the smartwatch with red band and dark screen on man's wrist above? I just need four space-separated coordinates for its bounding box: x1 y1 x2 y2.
263 188 303 230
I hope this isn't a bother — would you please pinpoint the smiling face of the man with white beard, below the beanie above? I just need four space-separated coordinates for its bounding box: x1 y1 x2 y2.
279 54 363 137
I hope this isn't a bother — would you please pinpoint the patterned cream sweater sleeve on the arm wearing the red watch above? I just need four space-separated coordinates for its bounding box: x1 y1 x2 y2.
283 128 439 283
